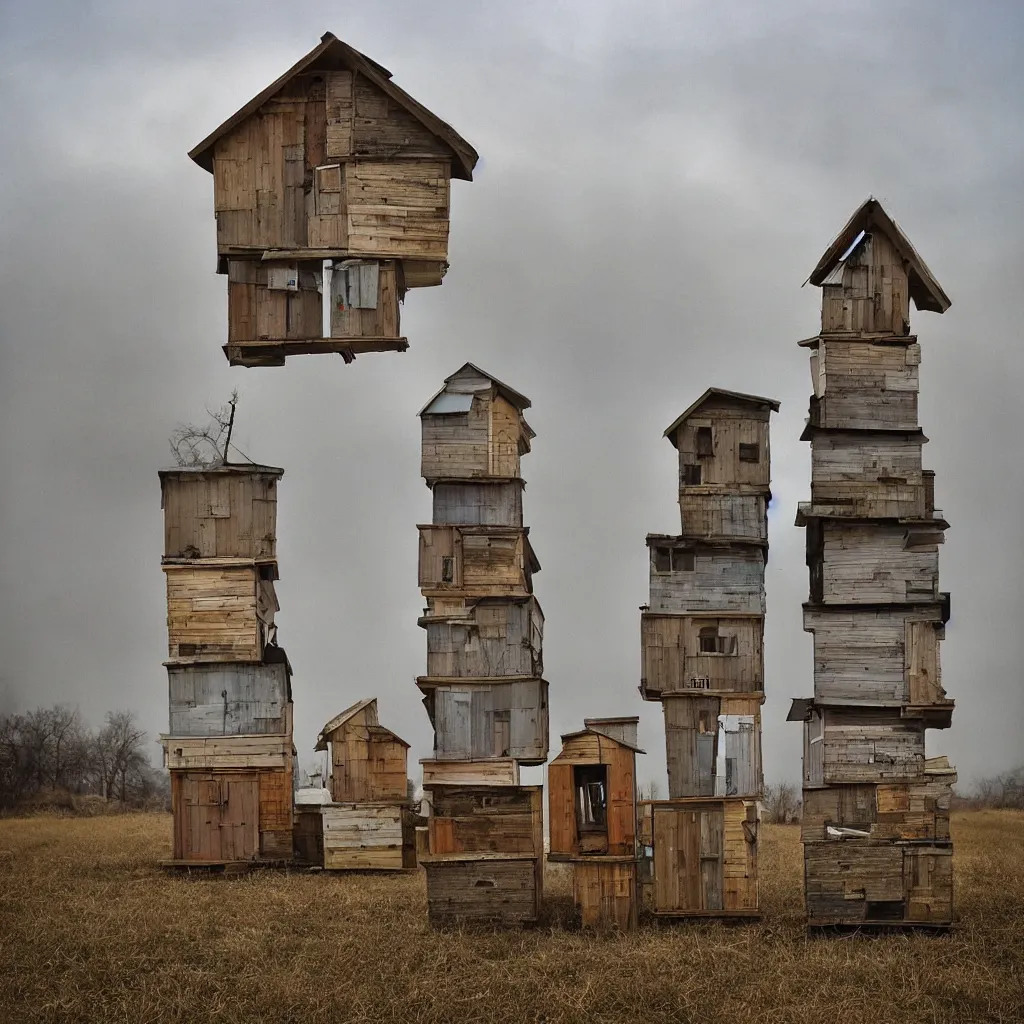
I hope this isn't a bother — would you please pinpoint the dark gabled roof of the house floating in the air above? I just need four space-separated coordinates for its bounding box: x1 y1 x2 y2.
188 32 479 181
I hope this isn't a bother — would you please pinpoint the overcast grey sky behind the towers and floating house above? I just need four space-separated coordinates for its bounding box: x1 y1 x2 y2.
0 0 1024 794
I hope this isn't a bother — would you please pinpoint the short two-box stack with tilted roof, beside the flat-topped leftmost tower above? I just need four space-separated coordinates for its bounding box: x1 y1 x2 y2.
303 697 417 870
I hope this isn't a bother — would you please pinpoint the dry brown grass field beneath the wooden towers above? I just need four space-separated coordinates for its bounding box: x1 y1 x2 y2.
0 811 1024 1024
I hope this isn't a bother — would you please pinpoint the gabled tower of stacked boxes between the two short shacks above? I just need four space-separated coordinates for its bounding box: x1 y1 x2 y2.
417 362 548 925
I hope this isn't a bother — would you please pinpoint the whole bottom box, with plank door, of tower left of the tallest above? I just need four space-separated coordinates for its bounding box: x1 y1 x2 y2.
651 800 758 916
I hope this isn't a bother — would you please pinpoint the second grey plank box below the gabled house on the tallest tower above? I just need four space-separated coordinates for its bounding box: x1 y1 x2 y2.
811 431 925 518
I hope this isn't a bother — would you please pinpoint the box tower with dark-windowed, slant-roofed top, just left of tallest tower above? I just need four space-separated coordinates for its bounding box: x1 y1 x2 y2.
640 388 778 918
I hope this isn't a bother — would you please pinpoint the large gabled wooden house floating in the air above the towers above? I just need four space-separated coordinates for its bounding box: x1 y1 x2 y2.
188 33 477 366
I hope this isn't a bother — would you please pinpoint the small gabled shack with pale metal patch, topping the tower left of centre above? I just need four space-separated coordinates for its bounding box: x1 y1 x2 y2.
420 362 535 483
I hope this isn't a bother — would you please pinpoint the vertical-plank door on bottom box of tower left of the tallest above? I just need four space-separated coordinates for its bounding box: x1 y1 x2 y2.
653 804 725 914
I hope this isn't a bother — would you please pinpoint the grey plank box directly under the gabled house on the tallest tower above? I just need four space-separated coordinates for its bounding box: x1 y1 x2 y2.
810 338 921 430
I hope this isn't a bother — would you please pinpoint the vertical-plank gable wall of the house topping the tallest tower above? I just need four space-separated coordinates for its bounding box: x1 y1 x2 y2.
821 231 910 335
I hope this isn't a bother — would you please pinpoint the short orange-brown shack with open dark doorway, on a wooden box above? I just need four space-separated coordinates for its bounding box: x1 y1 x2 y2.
548 718 643 931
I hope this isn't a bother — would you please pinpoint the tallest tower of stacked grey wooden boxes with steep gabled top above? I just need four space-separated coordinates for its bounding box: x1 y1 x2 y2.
790 199 956 926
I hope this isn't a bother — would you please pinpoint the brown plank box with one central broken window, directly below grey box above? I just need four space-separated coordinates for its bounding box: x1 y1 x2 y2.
640 612 764 698
